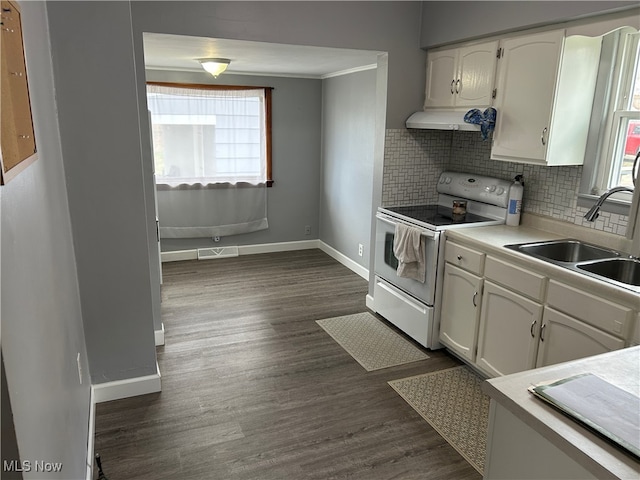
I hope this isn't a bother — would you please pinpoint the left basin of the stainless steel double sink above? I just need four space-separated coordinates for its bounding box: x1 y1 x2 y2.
505 240 620 263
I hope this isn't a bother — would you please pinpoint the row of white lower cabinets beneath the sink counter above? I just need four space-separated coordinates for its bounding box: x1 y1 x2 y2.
440 237 640 377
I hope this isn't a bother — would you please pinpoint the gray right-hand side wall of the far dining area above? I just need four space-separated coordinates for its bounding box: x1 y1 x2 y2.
320 70 377 269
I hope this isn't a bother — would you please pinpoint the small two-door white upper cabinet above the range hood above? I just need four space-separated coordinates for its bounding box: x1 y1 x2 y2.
424 40 498 109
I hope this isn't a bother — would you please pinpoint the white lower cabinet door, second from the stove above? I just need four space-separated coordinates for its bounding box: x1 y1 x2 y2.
476 281 542 377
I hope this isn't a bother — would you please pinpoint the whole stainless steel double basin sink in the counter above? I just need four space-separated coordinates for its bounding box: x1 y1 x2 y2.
505 240 640 293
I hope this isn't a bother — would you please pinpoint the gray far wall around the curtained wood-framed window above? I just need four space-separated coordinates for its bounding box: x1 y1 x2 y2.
146 70 322 251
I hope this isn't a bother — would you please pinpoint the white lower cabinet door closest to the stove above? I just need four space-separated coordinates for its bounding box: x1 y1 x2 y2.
440 263 482 362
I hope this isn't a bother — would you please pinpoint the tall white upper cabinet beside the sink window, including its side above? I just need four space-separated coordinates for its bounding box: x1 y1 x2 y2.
491 30 601 165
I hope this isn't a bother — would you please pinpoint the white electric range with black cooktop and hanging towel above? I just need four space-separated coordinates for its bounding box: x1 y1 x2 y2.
373 172 511 349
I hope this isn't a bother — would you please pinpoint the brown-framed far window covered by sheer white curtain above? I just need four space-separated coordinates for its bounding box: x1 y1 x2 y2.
147 82 272 187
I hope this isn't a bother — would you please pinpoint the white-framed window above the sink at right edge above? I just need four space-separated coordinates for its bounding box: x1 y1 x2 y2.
582 27 640 204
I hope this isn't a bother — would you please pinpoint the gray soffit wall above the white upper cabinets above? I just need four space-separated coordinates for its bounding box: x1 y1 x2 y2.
420 1 638 48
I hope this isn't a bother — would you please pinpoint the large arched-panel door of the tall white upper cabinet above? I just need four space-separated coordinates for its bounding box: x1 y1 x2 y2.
491 31 564 163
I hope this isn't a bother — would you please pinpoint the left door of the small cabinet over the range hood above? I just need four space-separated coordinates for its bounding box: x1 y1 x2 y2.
424 49 458 107
